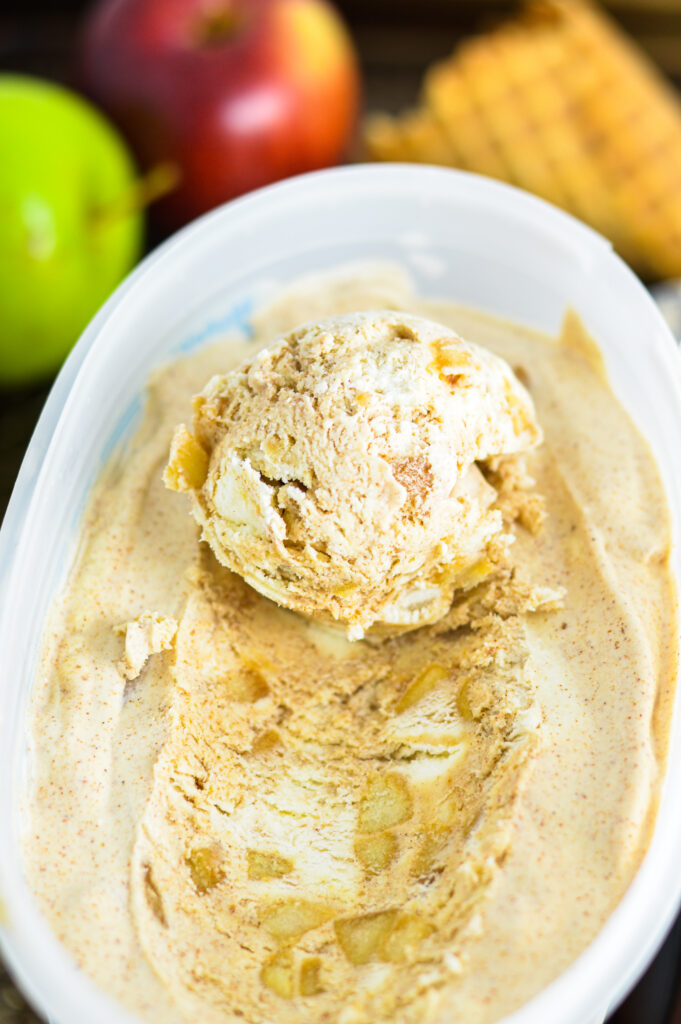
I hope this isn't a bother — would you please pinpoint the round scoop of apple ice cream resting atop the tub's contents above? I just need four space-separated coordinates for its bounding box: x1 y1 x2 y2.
164 311 541 637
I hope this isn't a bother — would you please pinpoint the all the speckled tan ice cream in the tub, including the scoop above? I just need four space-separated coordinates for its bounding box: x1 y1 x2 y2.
25 265 677 1024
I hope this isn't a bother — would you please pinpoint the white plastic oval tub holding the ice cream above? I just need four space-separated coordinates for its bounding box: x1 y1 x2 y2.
0 165 681 1024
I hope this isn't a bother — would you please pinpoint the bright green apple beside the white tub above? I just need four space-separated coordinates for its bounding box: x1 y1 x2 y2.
0 75 142 387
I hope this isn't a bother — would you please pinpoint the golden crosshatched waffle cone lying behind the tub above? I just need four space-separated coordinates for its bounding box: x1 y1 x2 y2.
365 0 681 278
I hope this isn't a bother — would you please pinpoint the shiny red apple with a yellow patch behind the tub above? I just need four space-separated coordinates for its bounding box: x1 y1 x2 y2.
81 0 359 227
